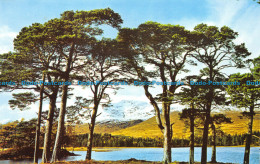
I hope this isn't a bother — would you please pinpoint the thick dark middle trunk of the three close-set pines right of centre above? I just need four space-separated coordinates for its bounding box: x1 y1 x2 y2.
201 111 210 164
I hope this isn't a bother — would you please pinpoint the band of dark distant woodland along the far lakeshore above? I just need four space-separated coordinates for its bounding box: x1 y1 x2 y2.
0 119 260 148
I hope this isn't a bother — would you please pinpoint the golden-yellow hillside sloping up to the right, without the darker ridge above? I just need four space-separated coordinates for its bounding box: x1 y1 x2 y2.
111 111 260 138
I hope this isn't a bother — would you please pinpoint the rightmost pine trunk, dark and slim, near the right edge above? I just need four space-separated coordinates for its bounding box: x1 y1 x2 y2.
244 106 254 164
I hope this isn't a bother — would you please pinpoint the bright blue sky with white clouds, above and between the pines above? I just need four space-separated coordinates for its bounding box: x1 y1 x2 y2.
0 0 260 122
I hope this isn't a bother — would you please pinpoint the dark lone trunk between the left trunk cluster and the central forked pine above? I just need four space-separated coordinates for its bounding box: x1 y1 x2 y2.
86 104 98 160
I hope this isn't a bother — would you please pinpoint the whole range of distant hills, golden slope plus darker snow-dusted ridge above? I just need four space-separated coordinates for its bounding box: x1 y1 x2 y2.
72 111 260 138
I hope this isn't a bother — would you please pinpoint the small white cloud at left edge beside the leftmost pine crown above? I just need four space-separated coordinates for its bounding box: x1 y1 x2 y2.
0 26 17 53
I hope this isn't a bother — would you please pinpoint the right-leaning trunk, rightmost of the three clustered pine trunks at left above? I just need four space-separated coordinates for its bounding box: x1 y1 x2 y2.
51 84 68 162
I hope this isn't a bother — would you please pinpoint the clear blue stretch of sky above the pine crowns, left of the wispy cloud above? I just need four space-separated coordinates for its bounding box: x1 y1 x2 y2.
0 0 209 31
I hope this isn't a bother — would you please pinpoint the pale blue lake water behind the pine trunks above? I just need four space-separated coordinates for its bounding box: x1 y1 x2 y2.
0 147 260 164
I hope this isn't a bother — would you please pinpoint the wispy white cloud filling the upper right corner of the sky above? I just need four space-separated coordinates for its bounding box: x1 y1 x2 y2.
205 0 260 58
